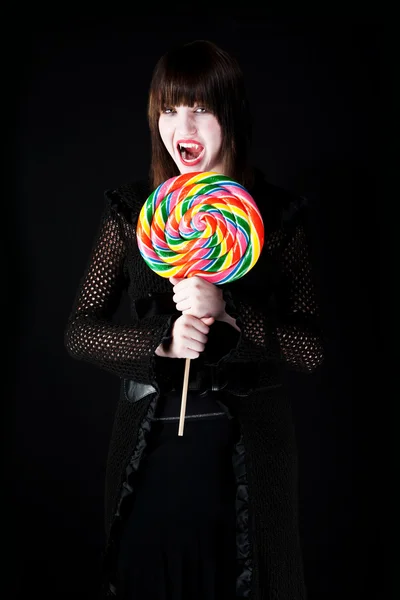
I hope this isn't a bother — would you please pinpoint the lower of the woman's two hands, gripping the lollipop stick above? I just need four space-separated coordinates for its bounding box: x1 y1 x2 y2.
156 314 215 359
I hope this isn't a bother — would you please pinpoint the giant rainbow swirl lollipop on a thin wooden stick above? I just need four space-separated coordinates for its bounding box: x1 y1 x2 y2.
136 171 264 435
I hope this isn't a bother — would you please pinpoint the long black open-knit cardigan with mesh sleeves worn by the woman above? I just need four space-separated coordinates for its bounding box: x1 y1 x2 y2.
65 174 323 600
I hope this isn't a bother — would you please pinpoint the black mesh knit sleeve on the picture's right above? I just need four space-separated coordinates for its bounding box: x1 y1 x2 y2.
220 199 323 372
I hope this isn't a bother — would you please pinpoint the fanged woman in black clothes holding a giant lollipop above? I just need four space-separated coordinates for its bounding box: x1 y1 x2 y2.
65 41 322 600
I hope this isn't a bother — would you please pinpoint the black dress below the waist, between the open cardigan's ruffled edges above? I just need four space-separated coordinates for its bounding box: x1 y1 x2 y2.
117 392 236 600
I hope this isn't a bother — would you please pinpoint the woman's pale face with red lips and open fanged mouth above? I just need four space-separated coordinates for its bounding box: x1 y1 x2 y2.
158 106 223 175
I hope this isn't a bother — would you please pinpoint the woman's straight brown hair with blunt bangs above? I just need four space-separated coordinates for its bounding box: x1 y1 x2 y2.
148 40 251 189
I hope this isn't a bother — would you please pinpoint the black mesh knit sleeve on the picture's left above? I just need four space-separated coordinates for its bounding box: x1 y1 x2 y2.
65 198 171 383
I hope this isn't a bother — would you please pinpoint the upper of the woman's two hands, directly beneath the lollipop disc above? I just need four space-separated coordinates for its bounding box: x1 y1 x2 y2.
169 277 226 320
